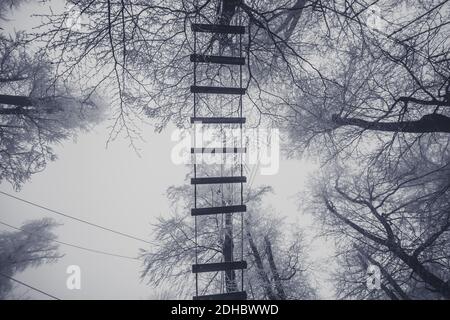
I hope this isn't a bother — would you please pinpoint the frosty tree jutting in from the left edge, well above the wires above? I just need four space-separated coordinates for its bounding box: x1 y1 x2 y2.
0 34 104 189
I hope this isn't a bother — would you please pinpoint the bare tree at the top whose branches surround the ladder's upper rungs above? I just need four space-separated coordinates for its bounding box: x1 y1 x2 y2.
37 0 326 130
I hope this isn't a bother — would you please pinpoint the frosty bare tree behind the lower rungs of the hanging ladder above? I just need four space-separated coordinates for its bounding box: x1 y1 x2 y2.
142 180 316 300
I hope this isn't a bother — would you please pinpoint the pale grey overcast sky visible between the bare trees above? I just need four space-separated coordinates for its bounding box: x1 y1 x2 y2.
0 0 332 299
